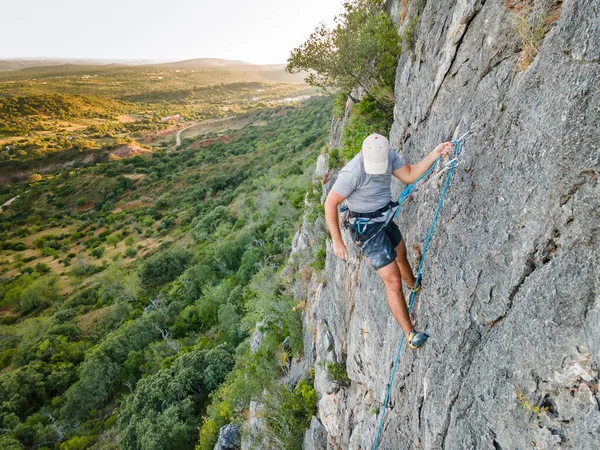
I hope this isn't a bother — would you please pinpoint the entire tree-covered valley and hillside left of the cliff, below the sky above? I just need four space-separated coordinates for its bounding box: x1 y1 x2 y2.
0 58 332 450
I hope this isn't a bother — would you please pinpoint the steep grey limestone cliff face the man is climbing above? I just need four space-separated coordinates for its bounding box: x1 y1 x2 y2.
300 0 600 449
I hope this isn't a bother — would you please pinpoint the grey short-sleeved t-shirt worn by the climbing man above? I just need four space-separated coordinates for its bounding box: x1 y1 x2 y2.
332 150 404 213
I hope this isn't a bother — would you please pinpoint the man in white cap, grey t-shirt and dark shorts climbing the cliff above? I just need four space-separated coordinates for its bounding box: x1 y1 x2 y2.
325 134 452 349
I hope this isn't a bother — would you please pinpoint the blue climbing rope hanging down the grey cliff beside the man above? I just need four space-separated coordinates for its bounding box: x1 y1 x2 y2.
373 131 471 450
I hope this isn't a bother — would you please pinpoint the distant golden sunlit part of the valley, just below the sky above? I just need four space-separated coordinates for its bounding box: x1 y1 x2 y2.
0 65 315 167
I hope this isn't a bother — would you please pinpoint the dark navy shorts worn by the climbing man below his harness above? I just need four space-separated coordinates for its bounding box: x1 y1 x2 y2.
349 220 402 270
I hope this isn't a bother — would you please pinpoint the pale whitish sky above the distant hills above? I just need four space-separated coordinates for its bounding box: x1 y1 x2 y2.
0 0 342 64
